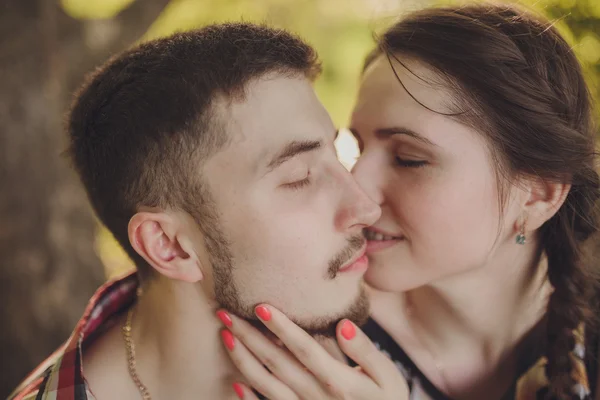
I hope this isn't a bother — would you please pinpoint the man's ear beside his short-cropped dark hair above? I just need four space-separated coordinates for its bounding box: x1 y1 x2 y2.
128 211 203 282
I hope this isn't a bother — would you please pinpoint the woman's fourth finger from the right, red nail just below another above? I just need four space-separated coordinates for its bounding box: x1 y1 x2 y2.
221 329 299 400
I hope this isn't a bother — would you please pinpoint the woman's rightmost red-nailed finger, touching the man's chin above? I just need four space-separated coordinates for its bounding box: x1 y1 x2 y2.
337 319 408 392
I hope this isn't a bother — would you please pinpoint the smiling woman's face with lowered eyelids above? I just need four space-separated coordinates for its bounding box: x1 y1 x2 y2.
350 56 520 291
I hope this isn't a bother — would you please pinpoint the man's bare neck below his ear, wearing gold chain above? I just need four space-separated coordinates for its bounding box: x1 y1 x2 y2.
132 279 243 399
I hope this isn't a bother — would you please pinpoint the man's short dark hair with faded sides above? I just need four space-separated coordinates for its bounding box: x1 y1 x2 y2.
67 23 320 275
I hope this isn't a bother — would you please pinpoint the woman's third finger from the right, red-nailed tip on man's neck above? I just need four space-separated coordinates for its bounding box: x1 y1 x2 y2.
217 310 325 400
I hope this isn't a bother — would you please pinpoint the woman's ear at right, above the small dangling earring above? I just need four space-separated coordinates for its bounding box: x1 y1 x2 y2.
523 179 571 231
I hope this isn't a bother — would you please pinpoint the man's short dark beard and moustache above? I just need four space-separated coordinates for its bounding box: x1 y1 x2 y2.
205 212 369 337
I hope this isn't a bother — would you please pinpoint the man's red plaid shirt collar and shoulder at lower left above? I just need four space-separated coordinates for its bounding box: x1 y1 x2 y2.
8 273 139 400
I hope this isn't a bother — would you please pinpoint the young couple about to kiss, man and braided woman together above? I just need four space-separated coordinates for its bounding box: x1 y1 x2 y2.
12 5 600 400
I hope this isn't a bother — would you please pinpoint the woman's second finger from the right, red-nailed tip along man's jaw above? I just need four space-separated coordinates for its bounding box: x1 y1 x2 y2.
256 304 346 386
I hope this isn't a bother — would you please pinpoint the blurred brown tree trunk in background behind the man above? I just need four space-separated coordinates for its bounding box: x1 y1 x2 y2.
0 0 168 398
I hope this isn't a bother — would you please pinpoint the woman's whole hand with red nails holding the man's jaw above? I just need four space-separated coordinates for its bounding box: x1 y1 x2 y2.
217 305 409 400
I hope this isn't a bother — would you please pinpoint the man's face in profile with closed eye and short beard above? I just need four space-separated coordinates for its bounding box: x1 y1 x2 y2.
203 75 380 334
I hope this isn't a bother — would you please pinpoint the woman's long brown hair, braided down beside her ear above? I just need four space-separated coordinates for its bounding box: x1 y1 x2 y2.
365 4 600 399
